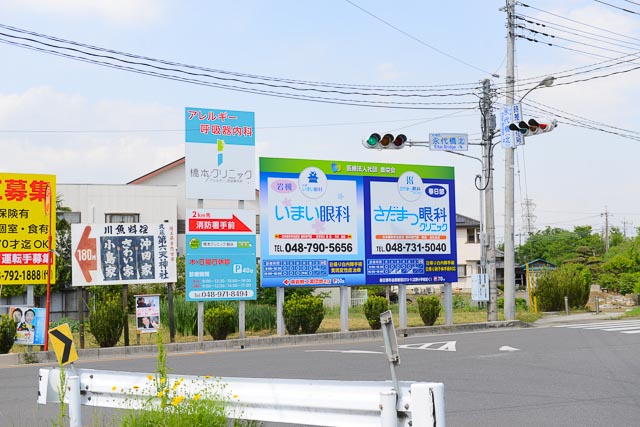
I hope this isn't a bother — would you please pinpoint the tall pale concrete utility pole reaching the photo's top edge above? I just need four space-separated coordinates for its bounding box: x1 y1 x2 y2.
504 0 516 320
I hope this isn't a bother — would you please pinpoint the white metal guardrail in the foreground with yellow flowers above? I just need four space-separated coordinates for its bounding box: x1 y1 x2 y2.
38 365 445 427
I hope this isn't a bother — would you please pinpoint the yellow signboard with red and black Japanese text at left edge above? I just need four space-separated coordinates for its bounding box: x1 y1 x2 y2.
0 173 56 285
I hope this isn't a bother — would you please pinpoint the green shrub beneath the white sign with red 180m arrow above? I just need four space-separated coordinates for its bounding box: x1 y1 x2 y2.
89 297 127 347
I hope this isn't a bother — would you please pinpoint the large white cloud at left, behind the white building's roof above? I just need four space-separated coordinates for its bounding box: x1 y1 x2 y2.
0 87 184 183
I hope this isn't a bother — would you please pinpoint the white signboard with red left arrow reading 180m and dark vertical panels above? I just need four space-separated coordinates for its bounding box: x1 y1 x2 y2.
71 223 177 286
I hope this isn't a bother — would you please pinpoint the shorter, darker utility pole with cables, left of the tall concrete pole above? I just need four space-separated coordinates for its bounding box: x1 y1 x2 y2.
480 79 498 322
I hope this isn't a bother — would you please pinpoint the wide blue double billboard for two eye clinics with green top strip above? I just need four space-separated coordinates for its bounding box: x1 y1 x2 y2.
260 158 458 287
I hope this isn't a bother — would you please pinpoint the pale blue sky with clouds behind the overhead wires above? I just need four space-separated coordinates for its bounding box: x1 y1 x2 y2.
0 0 640 244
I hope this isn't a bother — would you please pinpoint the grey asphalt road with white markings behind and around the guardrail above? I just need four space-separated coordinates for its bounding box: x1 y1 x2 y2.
0 321 640 427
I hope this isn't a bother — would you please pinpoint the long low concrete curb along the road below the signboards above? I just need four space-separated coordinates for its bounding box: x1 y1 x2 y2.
0 320 531 368
